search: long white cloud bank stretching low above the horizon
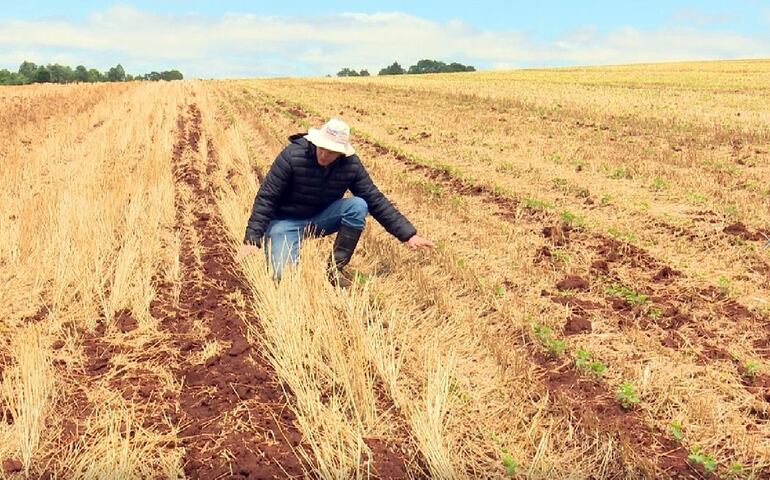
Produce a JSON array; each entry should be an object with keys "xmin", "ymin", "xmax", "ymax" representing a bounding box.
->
[{"xmin": 0, "ymin": 6, "xmax": 770, "ymax": 77}]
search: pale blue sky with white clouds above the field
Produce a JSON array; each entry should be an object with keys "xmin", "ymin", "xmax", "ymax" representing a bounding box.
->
[{"xmin": 0, "ymin": 0, "xmax": 770, "ymax": 78}]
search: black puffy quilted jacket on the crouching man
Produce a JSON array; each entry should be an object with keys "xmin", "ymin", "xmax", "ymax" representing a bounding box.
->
[{"xmin": 244, "ymin": 133, "xmax": 417, "ymax": 245}]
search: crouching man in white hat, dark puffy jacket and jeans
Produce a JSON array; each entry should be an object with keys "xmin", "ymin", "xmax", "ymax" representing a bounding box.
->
[{"xmin": 236, "ymin": 119, "xmax": 434, "ymax": 287}]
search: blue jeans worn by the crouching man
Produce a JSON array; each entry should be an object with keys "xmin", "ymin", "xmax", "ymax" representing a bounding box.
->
[{"xmin": 264, "ymin": 197, "xmax": 369, "ymax": 280}]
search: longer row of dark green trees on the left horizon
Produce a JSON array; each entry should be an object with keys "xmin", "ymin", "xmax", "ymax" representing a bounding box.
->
[{"xmin": 0, "ymin": 61, "xmax": 184, "ymax": 85}]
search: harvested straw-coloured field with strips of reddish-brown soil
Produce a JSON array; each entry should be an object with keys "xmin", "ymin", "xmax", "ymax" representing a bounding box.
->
[{"xmin": 0, "ymin": 61, "xmax": 770, "ymax": 479}]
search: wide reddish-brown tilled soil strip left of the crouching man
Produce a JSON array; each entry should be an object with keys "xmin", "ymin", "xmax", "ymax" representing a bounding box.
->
[{"xmin": 151, "ymin": 104, "xmax": 307, "ymax": 479}]
